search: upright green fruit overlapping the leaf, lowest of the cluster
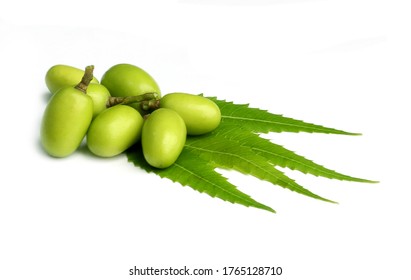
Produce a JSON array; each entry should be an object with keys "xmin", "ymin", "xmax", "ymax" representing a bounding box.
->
[{"xmin": 141, "ymin": 108, "xmax": 187, "ymax": 168}]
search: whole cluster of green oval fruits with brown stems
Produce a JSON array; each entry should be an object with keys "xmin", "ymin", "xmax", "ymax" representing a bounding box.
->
[{"xmin": 40, "ymin": 64, "xmax": 221, "ymax": 168}]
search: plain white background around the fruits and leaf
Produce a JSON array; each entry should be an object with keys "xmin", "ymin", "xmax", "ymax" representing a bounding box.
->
[{"xmin": 0, "ymin": 0, "xmax": 411, "ymax": 280}]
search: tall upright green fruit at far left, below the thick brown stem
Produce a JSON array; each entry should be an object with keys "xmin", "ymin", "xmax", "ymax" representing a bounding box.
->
[{"xmin": 40, "ymin": 87, "xmax": 93, "ymax": 157}]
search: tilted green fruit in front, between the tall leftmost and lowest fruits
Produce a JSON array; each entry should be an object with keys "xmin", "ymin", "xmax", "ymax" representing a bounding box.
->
[{"xmin": 87, "ymin": 105, "xmax": 143, "ymax": 157}]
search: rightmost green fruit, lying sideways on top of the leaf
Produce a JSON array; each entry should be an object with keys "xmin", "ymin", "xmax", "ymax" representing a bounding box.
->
[{"xmin": 160, "ymin": 92, "xmax": 221, "ymax": 135}]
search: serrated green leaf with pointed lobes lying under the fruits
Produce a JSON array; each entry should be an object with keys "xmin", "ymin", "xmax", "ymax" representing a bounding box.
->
[{"xmin": 126, "ymin": 97, "xmax": 373, "ymax": 212}]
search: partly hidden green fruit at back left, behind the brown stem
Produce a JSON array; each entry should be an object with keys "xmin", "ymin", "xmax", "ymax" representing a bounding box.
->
[{"xmin": 46, "ymin": 64, "xmax": 98, "ymax": 94}]
